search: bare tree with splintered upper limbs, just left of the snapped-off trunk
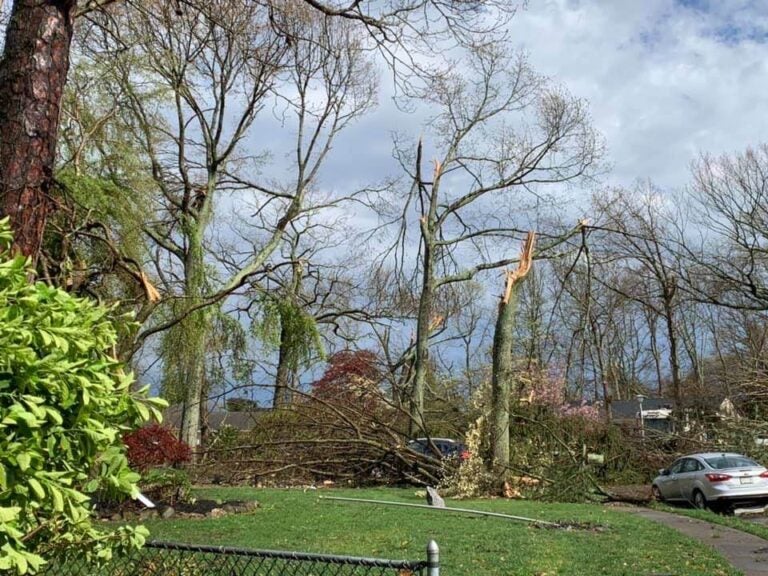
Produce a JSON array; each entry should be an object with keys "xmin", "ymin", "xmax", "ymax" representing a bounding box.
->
[{"xmin": 384, "ymin": 45, "xmax": 602, "ymax": 430}]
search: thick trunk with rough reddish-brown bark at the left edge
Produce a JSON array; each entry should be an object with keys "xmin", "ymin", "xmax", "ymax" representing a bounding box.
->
[{"xmin": 0, "ymin": 0, "xmax": 77, "ymax": 258}]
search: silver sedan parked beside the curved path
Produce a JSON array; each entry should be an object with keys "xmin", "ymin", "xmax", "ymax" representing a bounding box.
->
[{"xmin": 652, "ymin": 452, "xmax": 768, "ymax": 508}]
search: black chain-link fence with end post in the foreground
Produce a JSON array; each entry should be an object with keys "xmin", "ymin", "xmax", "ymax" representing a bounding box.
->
[{"xmin": 45, "ymin": 541, "xmax": 440, "ymax": 576}]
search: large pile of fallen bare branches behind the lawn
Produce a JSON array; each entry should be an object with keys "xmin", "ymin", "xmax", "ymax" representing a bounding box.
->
[{"xmin": 195, "ymin": 392, "xmax": 452, "ymax": 486}]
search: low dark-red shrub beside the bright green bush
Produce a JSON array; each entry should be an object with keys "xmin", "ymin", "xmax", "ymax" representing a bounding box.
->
[{"xmin": 123, "ymin": 424, "xmax": 191, "ymax": 472}]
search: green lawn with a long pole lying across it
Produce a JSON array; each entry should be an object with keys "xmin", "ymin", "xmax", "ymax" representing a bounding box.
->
[{"xmin": 132, "ymin": 488, "xmax": 739, "ymax": 576}]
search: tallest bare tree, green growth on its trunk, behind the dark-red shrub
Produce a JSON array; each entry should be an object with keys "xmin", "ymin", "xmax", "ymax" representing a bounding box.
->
[{"xmin": 78, "ymin": 0, "xmax": 375, "ymax": 446}]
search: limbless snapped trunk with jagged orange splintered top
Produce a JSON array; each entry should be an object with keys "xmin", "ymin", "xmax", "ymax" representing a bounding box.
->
[{"xmin": 491, "ymin": 232, "xmax": 535, "ymax": 475}]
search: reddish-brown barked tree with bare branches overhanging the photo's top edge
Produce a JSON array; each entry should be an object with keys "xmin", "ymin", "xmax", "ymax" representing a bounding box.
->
[{"xmin": 0, "ymin": 0, "xmax": 516, "ymax": 258}]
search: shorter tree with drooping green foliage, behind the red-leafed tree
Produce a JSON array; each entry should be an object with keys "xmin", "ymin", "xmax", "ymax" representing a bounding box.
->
[{"xmin": 235, "ymin": 213, "xmax": 374, "ymax": 408}]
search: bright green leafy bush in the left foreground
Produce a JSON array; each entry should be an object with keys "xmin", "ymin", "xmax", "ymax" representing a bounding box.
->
[{"xmin": 0, "ymin": 219, "xmax": 166, "ymax": 574}]
